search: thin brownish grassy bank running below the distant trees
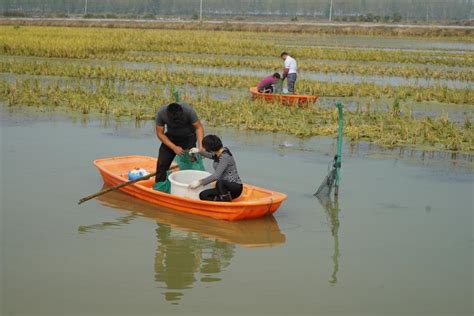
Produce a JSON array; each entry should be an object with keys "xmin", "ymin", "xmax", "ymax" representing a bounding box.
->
[{"xmin": 0, "ymin": 20, "xmax": 474, "ymax": 38}]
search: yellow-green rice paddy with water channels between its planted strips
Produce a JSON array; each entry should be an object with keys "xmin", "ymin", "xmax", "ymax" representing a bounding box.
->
[{"xmin": 0, "ymin": 26, "xmax": 474, "ymax": 153}]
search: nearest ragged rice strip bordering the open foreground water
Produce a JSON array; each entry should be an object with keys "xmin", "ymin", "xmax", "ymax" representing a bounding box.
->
[{"xmin": 0, "ymin": 80, "xmax": 474, "ymax": 153}]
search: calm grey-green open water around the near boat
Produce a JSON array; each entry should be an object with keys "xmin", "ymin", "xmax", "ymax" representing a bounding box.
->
[{"xmin": 0, "ymin": 108, "xmax": 474, "ymax": 315}]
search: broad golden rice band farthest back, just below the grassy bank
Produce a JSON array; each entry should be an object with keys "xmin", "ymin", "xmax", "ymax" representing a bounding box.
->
[{"xmin": 0, "ymin": 26, "xmax": 474, "ymax": 67}]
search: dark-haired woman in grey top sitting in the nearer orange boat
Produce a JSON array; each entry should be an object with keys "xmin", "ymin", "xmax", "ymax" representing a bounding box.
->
[{"xmin": 189, "ymin": 135, "xmax": 243, "ymax": 202}]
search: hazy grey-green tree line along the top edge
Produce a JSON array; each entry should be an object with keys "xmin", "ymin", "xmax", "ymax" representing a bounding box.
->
[{"xmin": 0, "ymin": 0, "xmax": 474, "ymax": 22}]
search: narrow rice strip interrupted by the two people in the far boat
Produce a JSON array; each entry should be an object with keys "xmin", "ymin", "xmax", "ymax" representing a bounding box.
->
[{"xmin": 0, "ymin": 61, "xmax": 474, "ymax": 104}]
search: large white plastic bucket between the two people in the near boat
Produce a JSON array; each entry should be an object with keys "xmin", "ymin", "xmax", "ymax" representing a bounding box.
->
[{"xmin": 168, "ymin": 170, "xmax": 213, "ymax": 200}]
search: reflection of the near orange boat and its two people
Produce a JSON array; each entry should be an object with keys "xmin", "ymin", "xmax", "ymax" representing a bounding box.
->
[{"xmin": 78, "ymin": 192, "xmax": 286, "ymax": 304}]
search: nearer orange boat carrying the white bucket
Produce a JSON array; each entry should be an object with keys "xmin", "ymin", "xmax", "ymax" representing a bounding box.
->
[{"xmin": 94, "ymin": 156, "xmax": 287, "ymax": 221}]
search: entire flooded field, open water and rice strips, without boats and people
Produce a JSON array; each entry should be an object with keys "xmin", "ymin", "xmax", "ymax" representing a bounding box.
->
[{"xmin": 0, "ymin": 26, "xmax": 474, "ymax": 315}]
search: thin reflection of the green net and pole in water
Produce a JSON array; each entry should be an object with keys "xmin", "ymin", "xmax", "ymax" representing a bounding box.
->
[{"xmin": 317, "ymin": 197, "xmax": 341, "ymax": 284}]
